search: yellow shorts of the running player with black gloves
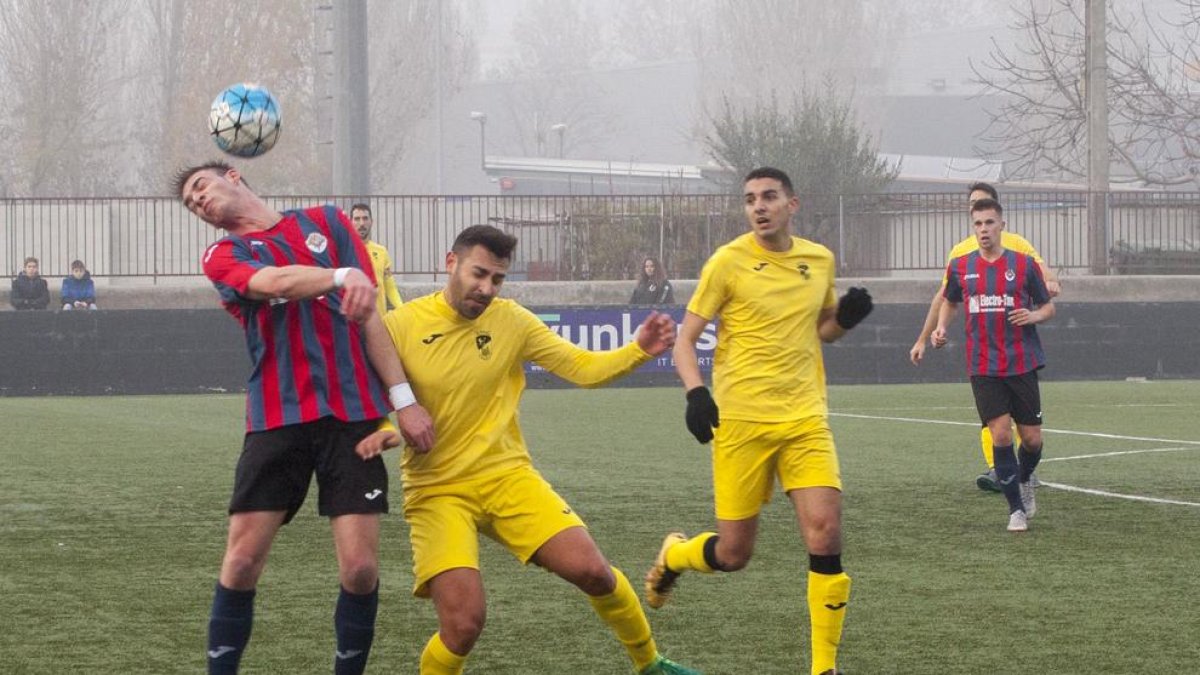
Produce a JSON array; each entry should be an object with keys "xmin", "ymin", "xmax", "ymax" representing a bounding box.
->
[{"xmin": 713, "ymin": 416, "xmax": 841, "ymax": 520}]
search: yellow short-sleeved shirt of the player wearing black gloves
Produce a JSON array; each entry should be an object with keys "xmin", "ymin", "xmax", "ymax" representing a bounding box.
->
[{"xmin": 688, "ymin": 233, "xmax": 838, "ymax": 422}]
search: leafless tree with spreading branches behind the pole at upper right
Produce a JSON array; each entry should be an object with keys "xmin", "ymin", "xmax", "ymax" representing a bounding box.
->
[{"xmin": 972, "ymin": 0, "xmax": 1200, "ymax": 186}]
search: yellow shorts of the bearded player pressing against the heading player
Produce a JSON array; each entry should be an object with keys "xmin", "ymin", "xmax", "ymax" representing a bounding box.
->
[{"xmin": 404, "ymin": 467, "xmax": 586, "ymax": 598}]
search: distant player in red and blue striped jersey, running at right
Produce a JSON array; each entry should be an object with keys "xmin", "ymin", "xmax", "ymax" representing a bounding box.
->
[{"xmin": 930, "ymin": 198, "xmax": 1055, "ymax": 532}]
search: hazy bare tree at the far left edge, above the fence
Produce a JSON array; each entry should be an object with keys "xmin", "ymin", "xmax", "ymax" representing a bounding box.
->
[{"xmin": 0, "ymin": 0, "xmax": 136, "ymax": 197}]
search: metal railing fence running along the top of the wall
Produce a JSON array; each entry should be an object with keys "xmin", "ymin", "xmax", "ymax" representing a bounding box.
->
[{"xmin": 0, "ymin": 191, "xmax": 1200, "ymax": 281}]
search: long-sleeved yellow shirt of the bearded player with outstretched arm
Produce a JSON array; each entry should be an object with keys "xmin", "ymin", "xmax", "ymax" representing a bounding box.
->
[{"xmin": 384, "ymin": 291, "xmax": 650, "ymax": 488}]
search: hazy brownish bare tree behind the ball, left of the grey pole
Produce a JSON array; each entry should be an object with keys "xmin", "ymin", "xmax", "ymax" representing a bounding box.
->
[{"xmin": 133, "ymin": 0, "xmax": 329, "ymax": 193}]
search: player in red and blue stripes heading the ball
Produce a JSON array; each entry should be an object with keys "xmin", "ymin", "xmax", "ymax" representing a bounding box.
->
[{"xmin": 175, "ymin": 162, "xmax": 434, "ymax": 675}]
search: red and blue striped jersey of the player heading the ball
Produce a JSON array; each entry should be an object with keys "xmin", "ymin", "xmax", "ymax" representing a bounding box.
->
[{"xmin": 204, "ymin": 205, "xmax": 391, "ymax": 431}]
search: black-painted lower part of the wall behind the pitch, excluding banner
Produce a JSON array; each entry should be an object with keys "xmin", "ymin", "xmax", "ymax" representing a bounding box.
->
[{"xmin": 0, "ymin": 301, "xmax": 1200, "ymax": 396}]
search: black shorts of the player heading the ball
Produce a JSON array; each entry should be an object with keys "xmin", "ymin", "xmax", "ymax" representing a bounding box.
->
[{"xmin": 229, "ymin": 417, "xmax": 388, "ymax": 522}]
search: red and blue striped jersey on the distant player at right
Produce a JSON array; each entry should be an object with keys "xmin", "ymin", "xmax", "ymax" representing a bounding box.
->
[{"xmin": 943, "ymin": 249, "xmax": 1050, "ymax": 377}]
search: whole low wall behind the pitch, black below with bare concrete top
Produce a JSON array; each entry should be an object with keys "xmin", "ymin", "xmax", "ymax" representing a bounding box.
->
[{"xmin": 0, "ymin": 277, "xmax": 1200, "ymax": 395}]
